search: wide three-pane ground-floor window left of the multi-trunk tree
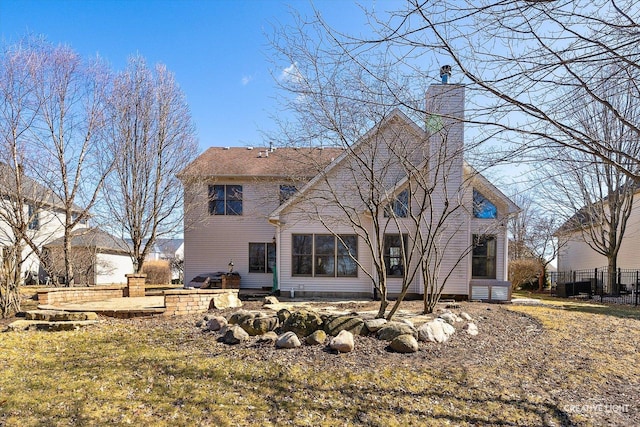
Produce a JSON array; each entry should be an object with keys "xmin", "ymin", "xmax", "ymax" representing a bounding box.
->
[{"xmin": 292, "ymin": 234, "xmax": 358, "ymax": 277}]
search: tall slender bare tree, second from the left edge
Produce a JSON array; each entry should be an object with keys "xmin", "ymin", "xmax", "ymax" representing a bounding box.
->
[{"xmin": 23, "ymin": 41, "xmax": 110, "ymax": 285}]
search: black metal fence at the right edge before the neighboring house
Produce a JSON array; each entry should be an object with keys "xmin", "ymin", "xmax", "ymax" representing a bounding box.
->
[{"xmin": 551, "ymin": 267, "xmax": 640, "ymax": 305}]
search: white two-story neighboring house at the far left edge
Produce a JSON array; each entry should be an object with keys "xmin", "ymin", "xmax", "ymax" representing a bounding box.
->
[{"xmin": 0, "ymin": 163, "xmax": 85, "ymax": 282}]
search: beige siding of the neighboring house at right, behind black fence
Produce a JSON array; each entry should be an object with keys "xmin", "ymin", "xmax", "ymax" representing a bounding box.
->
[{"xmin": 558, "ymin": 193, "xmax": 640, "ymax": 272}]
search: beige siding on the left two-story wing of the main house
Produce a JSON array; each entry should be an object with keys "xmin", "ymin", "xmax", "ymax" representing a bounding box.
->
[{"xmin": 184, "ymin": 180, "xmax": 280, "ymax": 288}]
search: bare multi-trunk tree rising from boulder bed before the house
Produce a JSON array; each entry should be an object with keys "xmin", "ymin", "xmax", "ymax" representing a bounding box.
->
[{"xmin": 273, "ymin": 16, "xmax": 508, "ymax": 318}]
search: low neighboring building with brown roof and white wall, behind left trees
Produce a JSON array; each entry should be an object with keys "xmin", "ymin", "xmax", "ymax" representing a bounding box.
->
[{"xmin": 45, "ymin": 228, "xmax": 134, "ymax": 285}]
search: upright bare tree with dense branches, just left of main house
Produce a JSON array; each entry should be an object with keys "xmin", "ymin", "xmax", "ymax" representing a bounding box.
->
[{"xmin": 104, "ymin": 56, "xmax": 197, "ymax": 272}]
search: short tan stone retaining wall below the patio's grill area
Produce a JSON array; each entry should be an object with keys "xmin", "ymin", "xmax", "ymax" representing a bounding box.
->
[{"xmin": 163, "ymin": 289, "xmax": 241, "ymax": 316}]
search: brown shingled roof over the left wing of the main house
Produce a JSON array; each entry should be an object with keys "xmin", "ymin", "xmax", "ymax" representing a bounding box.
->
[{"xmin": 178, "ymin": 147, "xmax": 343, "ymax": 181}]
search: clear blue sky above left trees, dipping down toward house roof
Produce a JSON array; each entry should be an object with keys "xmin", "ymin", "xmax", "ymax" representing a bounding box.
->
[{"xmin": 0, "ymin": 0, "xmax": 380, "ymax": 154}]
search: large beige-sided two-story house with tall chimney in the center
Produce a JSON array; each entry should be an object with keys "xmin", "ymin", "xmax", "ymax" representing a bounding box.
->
[{"xmin": 180, "ymin": 84, "xmax": 518, "ymax": 299}]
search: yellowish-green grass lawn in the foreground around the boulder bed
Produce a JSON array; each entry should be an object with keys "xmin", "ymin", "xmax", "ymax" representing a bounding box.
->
[{"xmin": 0, "ymin": 305, "xmax": 640, "ymax": 426}]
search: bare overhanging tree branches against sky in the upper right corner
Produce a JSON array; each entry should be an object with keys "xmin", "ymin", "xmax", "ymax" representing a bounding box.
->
[{"xmin": 362, "ymin": 0, "xmax": 640, "ymax": 179}]
